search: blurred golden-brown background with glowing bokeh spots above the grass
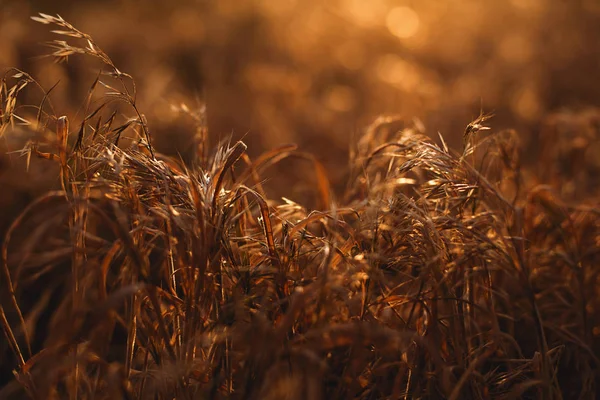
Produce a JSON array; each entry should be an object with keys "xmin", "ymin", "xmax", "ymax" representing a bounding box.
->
[{"xmin": 0, "ymin": 0, "xmax": 600, "ymax": 206}]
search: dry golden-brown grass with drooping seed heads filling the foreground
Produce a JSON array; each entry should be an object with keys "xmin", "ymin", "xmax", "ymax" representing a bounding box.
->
[{"xmin": 0, "ymin": 15, "xmax": 600, "ymax": 399}]
